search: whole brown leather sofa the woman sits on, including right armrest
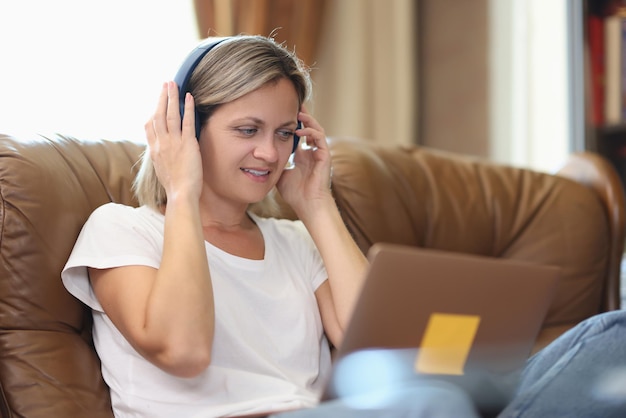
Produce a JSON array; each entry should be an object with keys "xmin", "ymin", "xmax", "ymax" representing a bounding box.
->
[{"xmin": 0, "ymin": 135, "xmax": 625, "ymax": 418}]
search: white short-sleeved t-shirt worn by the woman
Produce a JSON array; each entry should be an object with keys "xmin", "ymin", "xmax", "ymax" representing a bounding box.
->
[{"xmin": 62, "ymin": 203, "xmax": 331, "ymax": 418}]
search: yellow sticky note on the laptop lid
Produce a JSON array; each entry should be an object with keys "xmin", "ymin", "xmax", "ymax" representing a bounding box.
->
[{"xmin": 415, "ymin": 313, "xmax": 480, "ymax": 375}]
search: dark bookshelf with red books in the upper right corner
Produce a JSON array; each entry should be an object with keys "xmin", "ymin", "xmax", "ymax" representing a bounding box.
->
[{"xmin": 582, "ymin": 0, "xmax": 626, "ymax": 185}]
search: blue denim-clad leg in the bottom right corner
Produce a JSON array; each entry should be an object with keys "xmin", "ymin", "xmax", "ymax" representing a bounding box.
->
[{"xmin": 500, "ymin": 310, "xmax": 626, "ymax": 418}]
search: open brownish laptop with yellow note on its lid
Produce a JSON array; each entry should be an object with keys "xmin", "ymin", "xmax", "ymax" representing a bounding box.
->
[{"xmin": 322, "ymin": 243, "xmax": 560, "ymax": 416}]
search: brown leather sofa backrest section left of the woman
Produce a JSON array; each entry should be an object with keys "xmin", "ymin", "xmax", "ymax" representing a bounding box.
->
[{"xmin": 0, "ymin": 135, "xmax": 143, "ymax": 418}]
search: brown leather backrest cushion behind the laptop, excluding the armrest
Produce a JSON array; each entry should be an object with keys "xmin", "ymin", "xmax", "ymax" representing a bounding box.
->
[{"xmin": 332, "ymin": 140, "xmax": 610, "ymax": 332}]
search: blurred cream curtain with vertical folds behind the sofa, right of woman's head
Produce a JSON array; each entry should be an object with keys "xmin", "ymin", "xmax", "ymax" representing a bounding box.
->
[{"xmin": 310, "ymin": 0, "xmax": 419, "ymax": 144}]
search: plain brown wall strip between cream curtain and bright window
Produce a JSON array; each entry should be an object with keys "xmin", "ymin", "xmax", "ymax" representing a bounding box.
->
[{"xmin": 418, "ymin": 0, "xmax": 490, "ymax": 157}]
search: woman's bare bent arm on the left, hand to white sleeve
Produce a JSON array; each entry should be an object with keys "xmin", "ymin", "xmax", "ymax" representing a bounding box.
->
[{"xmin": 89, "ymin": 83, "xmax": 214, "ymax": 376}]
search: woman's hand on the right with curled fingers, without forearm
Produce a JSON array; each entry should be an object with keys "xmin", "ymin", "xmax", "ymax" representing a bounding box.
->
[{"xmin": 276, "ymin": 110, "xmax": 332, "ymax": 219}]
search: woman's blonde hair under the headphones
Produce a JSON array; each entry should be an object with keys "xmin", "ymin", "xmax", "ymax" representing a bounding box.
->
[{"xmin": 133, "ymin": 35, "xmax": 311, "ymax": 213}]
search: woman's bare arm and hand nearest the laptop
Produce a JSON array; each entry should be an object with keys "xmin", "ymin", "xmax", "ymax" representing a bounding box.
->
[{"xmin": 278, "ymin": 112, "xmax": 368, "ymax": 346}]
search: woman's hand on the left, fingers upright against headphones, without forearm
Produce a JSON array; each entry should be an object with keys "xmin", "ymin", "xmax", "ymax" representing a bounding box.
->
[{"xmin": 145, "ymin": 81, "xmax": 202, "ymax": 201}]
